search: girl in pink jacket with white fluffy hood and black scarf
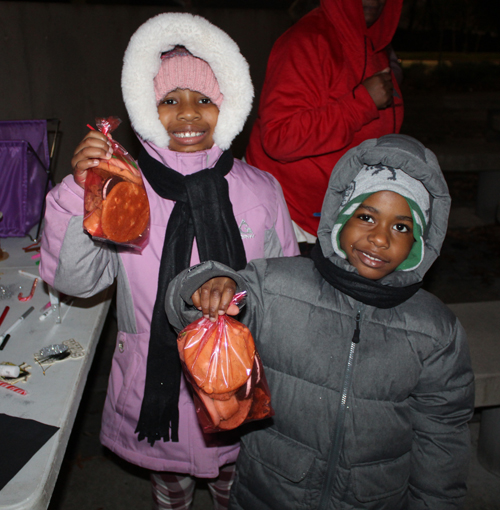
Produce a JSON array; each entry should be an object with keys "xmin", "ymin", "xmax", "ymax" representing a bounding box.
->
[{"xmin": 40, "ymin": 13, "xmax": 298, "ymax": 509}]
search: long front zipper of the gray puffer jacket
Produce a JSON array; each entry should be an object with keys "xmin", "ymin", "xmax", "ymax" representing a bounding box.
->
[{"xmin": 318, "ymin": 304, "xmax": 364, "ymax": 510}]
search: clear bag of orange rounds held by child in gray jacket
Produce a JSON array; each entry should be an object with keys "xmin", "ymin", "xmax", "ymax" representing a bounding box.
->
[{"xmin": 177, "ymin": 293, "xmax": 274, "ymax": 432}]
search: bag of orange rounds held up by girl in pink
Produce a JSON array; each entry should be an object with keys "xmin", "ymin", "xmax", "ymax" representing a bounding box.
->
[{"xmin": 83, "ymin": 117, "xmax": 149, "ymax": 249}]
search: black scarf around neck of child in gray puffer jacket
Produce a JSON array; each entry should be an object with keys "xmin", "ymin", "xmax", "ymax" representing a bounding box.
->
[{"xmin": 311, "ymin": 240, "xmax": 422, "ymax": 308}]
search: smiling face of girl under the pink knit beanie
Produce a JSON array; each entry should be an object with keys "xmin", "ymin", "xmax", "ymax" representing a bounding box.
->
[{"xmin": 158, "ymin": 89, "xmax": 219, "ymax": 152}]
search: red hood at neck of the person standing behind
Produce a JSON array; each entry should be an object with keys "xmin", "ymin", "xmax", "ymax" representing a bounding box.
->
[{"xmin": 320, "ymin": 0, "xmax": 403, "ymax": 52}]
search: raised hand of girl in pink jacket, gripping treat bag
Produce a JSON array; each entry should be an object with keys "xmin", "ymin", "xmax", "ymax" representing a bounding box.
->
[{"xmin": 71, "ymin": 131, "xmax": 113, "ymax": 188}]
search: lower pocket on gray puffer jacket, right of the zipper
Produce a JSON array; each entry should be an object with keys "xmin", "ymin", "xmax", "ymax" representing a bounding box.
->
[{"xmin": 351, "ymin": 452, "xmax": 410, "ymax": 502}]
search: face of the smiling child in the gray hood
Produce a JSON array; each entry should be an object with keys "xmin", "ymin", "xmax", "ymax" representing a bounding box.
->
[{"xmin": 340, "ymin": 191, "xmax": 414, "ymax": 280}]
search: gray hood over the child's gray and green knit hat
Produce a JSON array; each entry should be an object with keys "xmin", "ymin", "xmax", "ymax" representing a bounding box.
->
[{"xmin": 318, "ymin": 134, "xmax": 451, "ymax": 287}]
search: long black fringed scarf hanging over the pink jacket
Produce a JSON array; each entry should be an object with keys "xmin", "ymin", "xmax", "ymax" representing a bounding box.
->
[{"xmin": 135, "ymin": 145, "xmax": 246, "ymax": 446}]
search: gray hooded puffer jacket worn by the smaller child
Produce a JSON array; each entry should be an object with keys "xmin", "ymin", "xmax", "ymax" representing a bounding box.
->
[{"xmin": 166, "ymin": 135, "xmax": 474, "ymax": 510}]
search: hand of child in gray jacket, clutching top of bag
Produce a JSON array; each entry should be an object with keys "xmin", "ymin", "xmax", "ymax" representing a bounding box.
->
[{"xmin": 191, "ymin": 276, "xmax": 240, "ymax": 322}]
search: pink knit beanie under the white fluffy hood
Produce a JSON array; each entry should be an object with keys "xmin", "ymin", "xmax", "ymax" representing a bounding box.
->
[{"xmin": 154, "ymin": 46, "xmax": 224, "ymax": 110}]
